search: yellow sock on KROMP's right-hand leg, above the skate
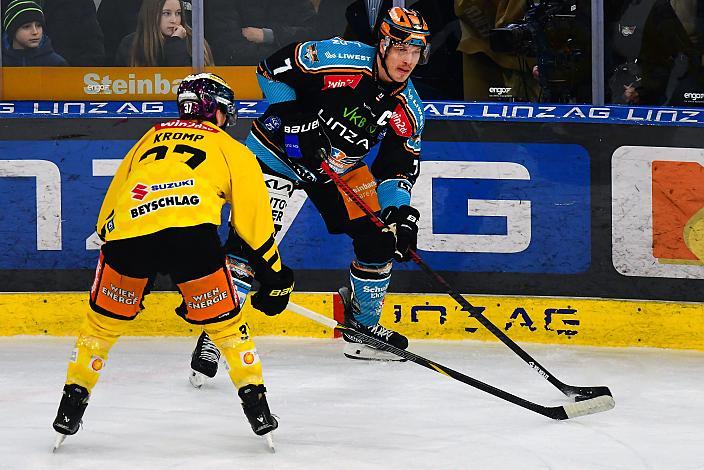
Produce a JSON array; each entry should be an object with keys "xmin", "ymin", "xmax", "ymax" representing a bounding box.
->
[{"xmin": 205, "ymin": 313, "xmax": 264, "ymax": 389}]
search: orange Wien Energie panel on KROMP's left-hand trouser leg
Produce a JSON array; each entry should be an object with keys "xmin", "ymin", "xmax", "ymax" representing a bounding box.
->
[{"xmin": 90, "ymin": 253, "xmax": 149, "ymax": 320}]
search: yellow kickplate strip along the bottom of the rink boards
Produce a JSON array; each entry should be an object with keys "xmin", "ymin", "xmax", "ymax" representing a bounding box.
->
[{"xmin": 0, "ymin": 292, "xmax": 704, "ymax": 350}]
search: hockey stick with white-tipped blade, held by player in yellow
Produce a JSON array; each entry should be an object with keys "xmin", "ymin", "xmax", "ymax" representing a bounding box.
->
[{"xmin": 286, "ymin": 302, "xmax": 616, "ymax": 420}]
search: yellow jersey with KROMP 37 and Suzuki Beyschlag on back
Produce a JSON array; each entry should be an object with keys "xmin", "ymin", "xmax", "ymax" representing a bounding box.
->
[{"xmin": 97, "ymin": 119, "xmax": 281, "ymax": 272}]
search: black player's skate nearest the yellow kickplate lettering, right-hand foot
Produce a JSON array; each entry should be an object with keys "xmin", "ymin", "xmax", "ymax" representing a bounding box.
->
[{"xmin": 338, "ymin": 287, "xmax": 408, "ymax": 362}]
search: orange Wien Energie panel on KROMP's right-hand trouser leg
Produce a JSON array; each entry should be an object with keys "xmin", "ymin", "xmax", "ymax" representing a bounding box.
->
[{"xmin": 176, "ymin": 268, "xmax": 240, "ymax": 325}]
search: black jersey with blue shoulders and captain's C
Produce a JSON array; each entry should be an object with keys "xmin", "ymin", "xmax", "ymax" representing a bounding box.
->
[{"xmin": 252, "ymin": 38, "xmax": 424, "ymax": 204}]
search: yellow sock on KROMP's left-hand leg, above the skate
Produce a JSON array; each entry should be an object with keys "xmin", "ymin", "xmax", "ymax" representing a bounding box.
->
[{"xmin": 66, "ymin": 310, "xmax": 129, "ymax": 392}]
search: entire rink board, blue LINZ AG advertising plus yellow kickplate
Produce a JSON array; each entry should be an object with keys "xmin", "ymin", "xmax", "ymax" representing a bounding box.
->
[{"xmin": 0, "ymin": 101, "xmax": 704, "ymax": 349}]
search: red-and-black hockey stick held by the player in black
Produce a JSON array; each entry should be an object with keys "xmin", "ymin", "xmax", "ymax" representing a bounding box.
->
[{"xmin": 321, "ymin": 161, "xmax": 612, "ymax": 400}]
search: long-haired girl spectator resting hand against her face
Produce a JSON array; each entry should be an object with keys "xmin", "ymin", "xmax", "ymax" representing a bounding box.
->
[{"xmin": 115, "ymin": 0, "xmax": 213, "ymax": 67}]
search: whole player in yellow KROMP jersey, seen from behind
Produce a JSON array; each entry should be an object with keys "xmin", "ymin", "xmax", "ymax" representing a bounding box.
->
[{"xmin": 54, "ymin": 73, "xmax": 293, "ymax": 449}]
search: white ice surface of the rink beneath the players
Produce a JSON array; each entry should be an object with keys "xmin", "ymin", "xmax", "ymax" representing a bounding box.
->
[{"xmin": 0, "ymin": 337, "xmax": 704, "ymax": 470}]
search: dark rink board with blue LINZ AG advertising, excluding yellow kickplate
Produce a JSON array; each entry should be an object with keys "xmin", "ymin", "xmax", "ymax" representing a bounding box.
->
[{"xmin": 0, "ymin": 101, "xmax": 704, "ymax": 303}]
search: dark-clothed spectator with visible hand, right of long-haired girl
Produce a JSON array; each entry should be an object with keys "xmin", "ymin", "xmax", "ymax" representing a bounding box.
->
[{"xmin": 204, "ymin": 0, "xmax": 316, "ymax": 65}]
